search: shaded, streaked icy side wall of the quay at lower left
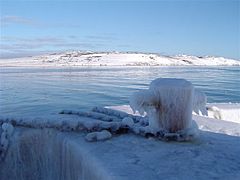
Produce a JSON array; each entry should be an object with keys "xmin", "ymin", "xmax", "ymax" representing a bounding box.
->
[{"xmin": 0, "ymin": 128, "xmax": 112, "ymax": 180}]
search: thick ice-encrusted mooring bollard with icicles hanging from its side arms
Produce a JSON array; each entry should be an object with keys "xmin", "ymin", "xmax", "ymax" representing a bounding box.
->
[{"xmin": 130, "ymin": 78, "xmax": 206, "ymax": 139}]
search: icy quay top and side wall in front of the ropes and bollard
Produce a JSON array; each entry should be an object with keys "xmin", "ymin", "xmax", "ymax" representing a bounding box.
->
[{"xmin": 0, "ymin": 125, "xmax": 240, "ymax": 180}]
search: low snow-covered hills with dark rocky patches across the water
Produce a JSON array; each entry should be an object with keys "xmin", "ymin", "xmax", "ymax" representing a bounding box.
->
[{"xmin": 0, "ymin": 51, "xmax": 240, "ymax": 67}]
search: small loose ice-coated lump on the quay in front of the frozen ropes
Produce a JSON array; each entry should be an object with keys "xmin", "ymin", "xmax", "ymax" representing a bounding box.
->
[{"xmin": 85, "ymin": 130, "xmax": 112, "ymax": 142}]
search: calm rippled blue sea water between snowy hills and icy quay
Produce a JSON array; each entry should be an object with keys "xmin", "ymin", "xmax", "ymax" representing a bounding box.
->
[{"xmin": 0, "ymin": 67, "xmax": 240, "ymax": 116}]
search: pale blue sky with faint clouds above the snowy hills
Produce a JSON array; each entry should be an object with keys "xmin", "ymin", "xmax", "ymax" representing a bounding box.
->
[{"xmin": 0, "ymin": 0, "xmax": 240, "ymax": 59}]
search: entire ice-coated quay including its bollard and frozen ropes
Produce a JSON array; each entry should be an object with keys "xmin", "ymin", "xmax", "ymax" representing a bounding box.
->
[{"xmin": 0, "ymin": 79, "xmax": 240, "ymax": 180}]
